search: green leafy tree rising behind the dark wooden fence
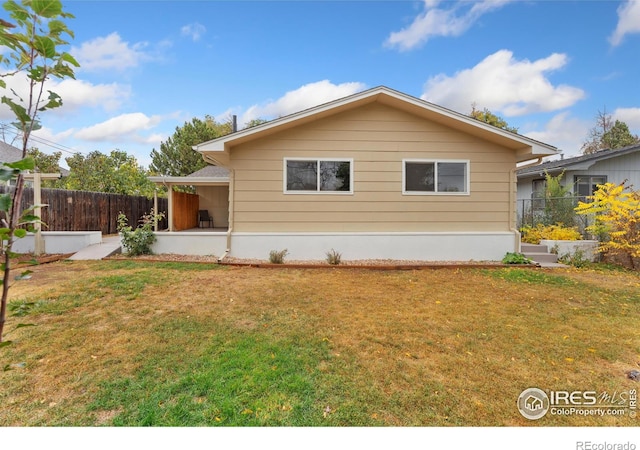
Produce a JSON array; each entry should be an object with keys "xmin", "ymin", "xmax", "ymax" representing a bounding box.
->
[{"xmin": 62, "ymin": 150, "xmax": 155, "ymax": 197}]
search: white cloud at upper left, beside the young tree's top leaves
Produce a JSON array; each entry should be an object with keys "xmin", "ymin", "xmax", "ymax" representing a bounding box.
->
[{"xmin": 70, "ymin": 32, "xmax": 150, "ymax": 72}]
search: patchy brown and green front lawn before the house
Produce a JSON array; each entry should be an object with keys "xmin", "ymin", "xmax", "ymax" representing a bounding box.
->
[{"xmin": 0, "ymin": 260, "xmax": 640, "ymax": 426}]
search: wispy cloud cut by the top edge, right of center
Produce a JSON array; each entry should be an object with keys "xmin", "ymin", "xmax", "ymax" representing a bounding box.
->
[{"xmin": 385, "ymin": 0, "xmax": 513, "ymax": 51}]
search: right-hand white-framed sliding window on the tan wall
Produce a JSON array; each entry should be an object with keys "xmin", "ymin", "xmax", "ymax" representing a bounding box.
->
[{"xmin": 402, "ymin": 159, "xmax": 469, "ymax": 195}]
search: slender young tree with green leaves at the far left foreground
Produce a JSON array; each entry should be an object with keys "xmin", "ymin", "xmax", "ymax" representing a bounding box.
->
[{"xmin": 0, "ymin": 0, "xmax": 79, "ymax": 342}]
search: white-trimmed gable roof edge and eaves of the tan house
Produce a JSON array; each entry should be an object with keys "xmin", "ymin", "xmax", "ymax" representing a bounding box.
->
[{"xmin": 193, "ymin": 86, "xmax": 558, "ymax": 166}]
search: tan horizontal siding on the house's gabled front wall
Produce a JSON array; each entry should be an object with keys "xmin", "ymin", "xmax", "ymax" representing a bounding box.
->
[{"xmin": 231, "ymin": 104, "xmax": 515, "ymax": 232}]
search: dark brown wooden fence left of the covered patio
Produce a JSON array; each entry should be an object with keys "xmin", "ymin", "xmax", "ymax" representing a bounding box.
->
[{"xmin": 0, "ymin": 186, "xmax": 168, "ymax": 234}]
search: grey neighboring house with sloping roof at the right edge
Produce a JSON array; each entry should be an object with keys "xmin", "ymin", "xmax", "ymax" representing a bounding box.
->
[{"xmin": 518, "ymin": 144, "xmax": 640, "ymax": 203}]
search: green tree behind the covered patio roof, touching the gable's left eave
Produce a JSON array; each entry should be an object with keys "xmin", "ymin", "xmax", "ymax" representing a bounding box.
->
[{"xmin": 149, "ymin": 116, "xmax": 232, "ymax": 177}]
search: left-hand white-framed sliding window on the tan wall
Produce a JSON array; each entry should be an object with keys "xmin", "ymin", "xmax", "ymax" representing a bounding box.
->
[{"xmin": 284, "ymin": 159, "xmax": 353, "ymax": 194}]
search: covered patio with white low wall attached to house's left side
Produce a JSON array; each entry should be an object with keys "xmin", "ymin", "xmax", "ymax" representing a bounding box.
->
[{"xmin": 149, "ymin": 166, "xmax": 229, "ymax": 257}]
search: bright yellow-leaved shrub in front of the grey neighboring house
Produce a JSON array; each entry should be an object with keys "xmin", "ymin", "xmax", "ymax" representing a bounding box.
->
[{"xmin": 576, "ymin": 182, "xmax": 640, "ymax": 269}]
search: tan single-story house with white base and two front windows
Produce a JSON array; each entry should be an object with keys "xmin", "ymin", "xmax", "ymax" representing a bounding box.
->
[{"xmin": 152, "ymin": 87, "xmax": 557, "ymax": 261}]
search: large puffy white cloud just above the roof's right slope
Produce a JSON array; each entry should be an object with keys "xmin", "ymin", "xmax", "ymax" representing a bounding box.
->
[{"xmin": 422, "ymin": 50, "xmax": 585, "ymax": 116}]
